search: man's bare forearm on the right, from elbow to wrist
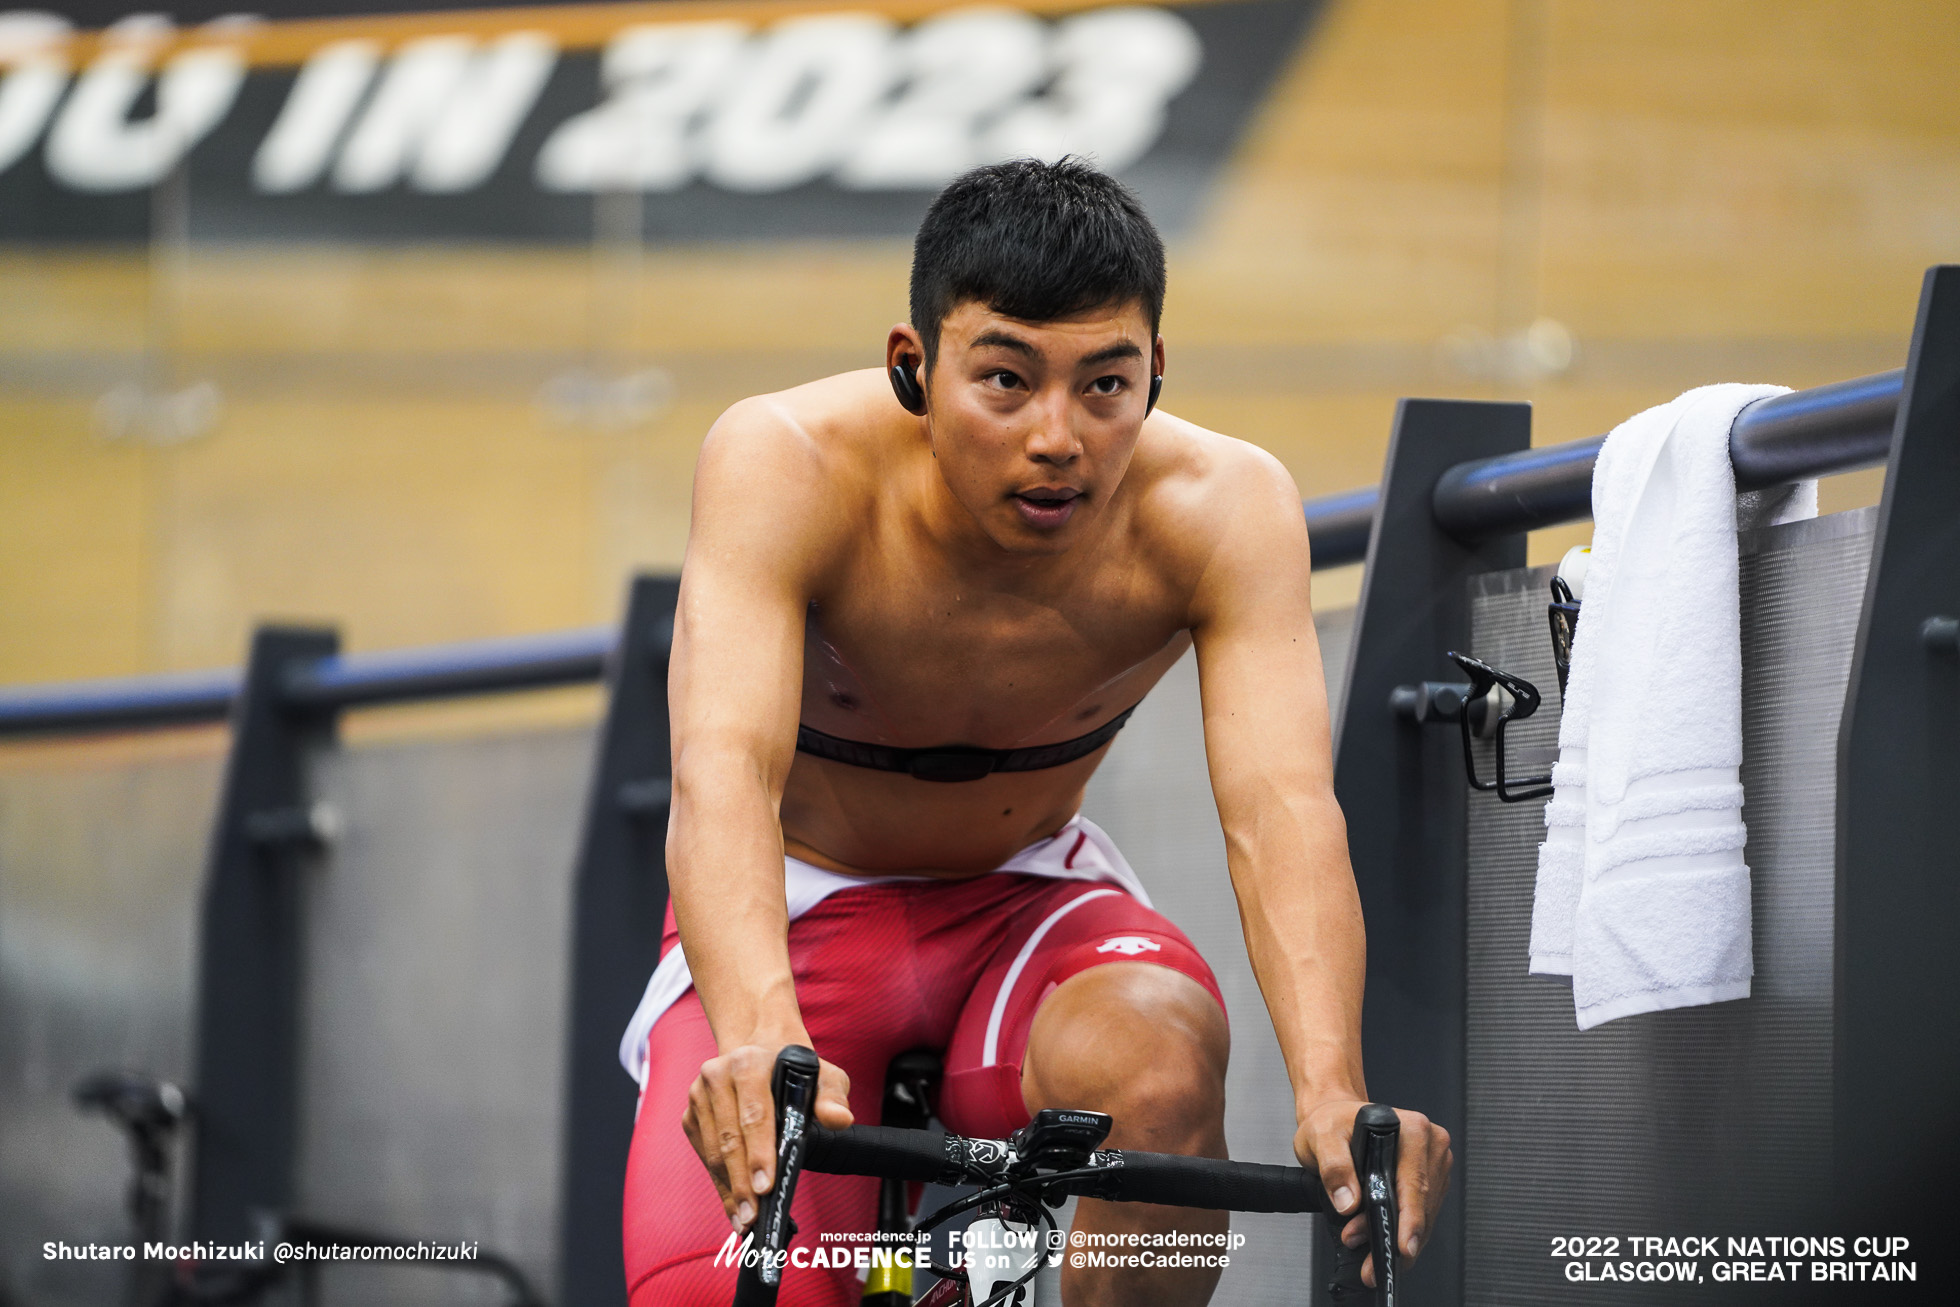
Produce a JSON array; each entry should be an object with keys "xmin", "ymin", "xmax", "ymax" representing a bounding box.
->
[{"xmin": 1227, "ymin": 798, "xmax": 1368, "ymax": 1109}]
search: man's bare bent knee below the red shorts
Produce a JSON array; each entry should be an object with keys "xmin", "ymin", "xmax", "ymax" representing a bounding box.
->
[{"xmin": 1021, "ymin": 962, "xmax": 1231, "ymax": 1150}]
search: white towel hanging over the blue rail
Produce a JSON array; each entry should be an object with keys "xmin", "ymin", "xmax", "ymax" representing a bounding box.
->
[{"xmin": 1531, "ymin": 384, "xmax": 1817, "ymax": 1029}]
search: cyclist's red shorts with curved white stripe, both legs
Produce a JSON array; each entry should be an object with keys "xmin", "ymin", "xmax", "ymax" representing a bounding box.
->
[{"xmin": 625, "ymin": 872, "xmax": 1225, "ymax": 1307}]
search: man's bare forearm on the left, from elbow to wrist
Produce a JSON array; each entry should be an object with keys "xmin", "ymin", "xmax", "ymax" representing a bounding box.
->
[{"xmin": 666, "ymin": 760, "xmax": 802, "ymax": 1048}]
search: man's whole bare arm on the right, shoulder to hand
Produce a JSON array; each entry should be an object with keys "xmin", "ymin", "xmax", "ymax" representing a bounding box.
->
[{"xmin": 1192, "ymin": 438, "xmax": 1450, "ymax": 1258}]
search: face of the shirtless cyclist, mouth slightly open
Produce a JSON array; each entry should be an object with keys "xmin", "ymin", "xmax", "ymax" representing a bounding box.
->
[{"xmin": 905, "ymin": 300, "xmax": 1162, "ymax": 555}]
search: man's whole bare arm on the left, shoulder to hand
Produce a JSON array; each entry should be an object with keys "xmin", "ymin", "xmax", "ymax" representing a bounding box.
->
[{"xmin": 666, "ymin": 400, "xmax": 851, "ymax": 1227}]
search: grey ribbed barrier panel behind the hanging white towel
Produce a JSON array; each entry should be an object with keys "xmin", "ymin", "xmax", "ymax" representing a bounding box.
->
[{"xmin": 1466, "ymin": 509, "xmax": 1876, "ymax": 1307}]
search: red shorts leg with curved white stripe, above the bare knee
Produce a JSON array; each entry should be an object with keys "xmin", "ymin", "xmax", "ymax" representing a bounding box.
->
[{"xmin": 939, "ymin": 880, "xmax": 1225, "ymax": 1138}]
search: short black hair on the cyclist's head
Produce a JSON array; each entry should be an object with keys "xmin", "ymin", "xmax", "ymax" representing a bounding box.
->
[{"xmin": 911, "ymin": 157, "xmax": 1164, "ymax": 364}]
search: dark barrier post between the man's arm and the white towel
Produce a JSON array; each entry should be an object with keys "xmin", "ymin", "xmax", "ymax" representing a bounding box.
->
[{"xmin": 1315, "ymin": 400, "xmax": 1531, "ymax": 1303}]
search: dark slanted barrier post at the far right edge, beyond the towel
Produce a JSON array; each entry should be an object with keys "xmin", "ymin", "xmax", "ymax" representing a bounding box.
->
[{"xmin": 1835, "ymin": 266, "xmax": 1960, "ymax": 1238}]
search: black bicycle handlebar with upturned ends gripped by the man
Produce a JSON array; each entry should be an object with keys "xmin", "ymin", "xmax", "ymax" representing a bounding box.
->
[{"xmin": 735, "ymin": 1044, "xmax": 1401, "ymax": 1307}]
